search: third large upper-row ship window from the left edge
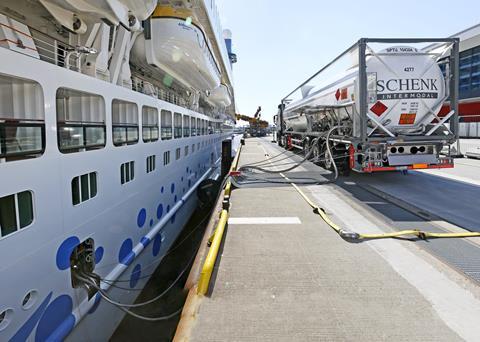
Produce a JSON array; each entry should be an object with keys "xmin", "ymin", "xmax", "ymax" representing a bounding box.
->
[{"xmin": 112, "ymin": 99, "xmax": 138, "ymax": 146}]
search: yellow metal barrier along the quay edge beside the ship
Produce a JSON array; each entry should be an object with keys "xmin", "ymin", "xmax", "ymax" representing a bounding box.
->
[{"xmin": 197, "ymin": 140, "xmax": 242, "ymax": 295}]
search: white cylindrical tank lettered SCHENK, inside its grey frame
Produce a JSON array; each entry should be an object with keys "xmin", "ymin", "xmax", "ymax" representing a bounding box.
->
[{"xmin": 284, "ymin": 46, "xmax": 446, "ymax": 134}]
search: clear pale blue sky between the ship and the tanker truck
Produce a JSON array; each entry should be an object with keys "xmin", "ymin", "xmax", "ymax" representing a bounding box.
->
[{"xmin": 216, "ymin": 0, "xmax": 480, "ymax": 122}]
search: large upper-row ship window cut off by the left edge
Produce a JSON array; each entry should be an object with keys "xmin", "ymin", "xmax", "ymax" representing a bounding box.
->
[{"xmin": 0, "ymin": 75, "xmax": 45, "ymax": 163}]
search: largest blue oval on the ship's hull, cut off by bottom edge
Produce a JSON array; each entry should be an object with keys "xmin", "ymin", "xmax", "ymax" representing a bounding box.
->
[{"xmin": 35, "ymin": 295, "xmax": 75, "ymax": 342}]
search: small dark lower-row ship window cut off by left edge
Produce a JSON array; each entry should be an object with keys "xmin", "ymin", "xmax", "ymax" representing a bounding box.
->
[{"xmin": 0, "ymin": 191, "xmax": 33, "ymax": 237}]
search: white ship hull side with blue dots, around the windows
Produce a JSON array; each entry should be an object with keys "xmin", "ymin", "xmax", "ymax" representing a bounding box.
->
[{"xmin": 0, "ymin": 49, "xmax": 230, "ymax": 341}]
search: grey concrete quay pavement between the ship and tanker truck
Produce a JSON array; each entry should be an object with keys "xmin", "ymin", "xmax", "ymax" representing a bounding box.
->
[{"xmin": 176, "ymin": 138, "xmax": 480, "ymax": 341}]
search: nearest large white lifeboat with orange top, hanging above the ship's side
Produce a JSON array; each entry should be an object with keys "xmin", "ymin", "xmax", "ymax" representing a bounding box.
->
[{"xmin": 132, "ymin": 6, "xmax": 220, "ymax": 91}]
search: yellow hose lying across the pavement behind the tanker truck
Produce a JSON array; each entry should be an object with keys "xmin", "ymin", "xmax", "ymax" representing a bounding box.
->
[{"xmin": 280, "ymin": 173, "xmax": 480, "ymax": 240}]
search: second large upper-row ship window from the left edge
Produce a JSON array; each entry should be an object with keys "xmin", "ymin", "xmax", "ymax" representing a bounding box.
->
[{"xmin": 56, "ymin": 88, "xmax": 105, "ymax": 153}]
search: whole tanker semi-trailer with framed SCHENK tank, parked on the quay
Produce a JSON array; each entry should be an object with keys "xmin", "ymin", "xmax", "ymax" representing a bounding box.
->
[{"xmin": 276, "ymin": 38, "xmax": 459, "ymax": 174}]
